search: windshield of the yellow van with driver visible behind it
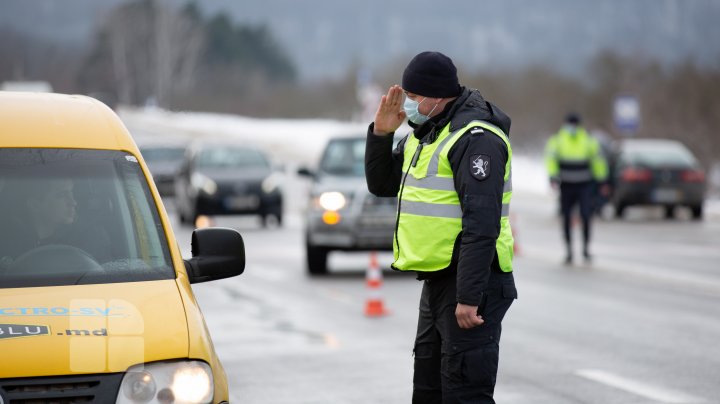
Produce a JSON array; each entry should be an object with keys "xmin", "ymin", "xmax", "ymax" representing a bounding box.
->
[{"xmin": 0, "ymin": 148, "xmax": 175, "ymax": 288}]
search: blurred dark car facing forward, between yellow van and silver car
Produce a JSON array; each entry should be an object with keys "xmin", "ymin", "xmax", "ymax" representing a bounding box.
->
[{"xmin": 175, "ymin": 140, "xmax": 283, "ymax": 226}]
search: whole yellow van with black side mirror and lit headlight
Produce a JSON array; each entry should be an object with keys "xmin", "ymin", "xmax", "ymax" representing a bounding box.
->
[{"xmin": 0, "ymin": 91, "xmax": 245, "ymax": 404}]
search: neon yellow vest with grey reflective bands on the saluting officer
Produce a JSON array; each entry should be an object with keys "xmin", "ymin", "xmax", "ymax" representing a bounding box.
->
[{"xmin": 392, "ymin": 121, "xmax": 514, "ymax": 272}]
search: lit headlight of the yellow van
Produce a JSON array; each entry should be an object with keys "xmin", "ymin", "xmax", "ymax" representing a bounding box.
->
[{"xmin": 116, "ymin": 361, "xmax": 215, "ymax": 404}]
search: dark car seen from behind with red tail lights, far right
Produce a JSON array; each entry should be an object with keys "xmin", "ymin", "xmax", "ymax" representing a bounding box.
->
[{"xmin": 611, "ymin": 139, "xmax": 705, "ymax": 219}]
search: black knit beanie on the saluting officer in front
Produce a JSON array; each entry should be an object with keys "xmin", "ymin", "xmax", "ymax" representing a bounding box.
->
[{"xmin": 402, "ymin": 52, "xmax": 460, "ymax": 98}]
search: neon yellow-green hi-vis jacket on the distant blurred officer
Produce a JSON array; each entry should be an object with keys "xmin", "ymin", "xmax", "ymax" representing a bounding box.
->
[{"xmin": 545, "ymin": 127, "xmax": 608, "ymax": 183}]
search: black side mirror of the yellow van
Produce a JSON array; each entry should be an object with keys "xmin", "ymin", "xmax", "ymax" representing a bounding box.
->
[{"xmin": 185, "ymin": 227, "xmax": 245, "ymax": 283}]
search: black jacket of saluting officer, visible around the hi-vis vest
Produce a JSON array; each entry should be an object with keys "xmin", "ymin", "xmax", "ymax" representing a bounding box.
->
[{"xmin": 365, "ymin": 88, "xmax": 510, "ymax": 306}]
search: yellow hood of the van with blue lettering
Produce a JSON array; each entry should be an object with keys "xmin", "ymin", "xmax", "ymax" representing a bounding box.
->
[{"xmin": 0, "ymin": 280, "xmax": 188, "ymax": 378}]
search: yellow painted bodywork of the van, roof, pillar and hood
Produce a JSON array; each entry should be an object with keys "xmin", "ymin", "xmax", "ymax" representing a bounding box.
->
[{"xmin": 0, "ymin": 91, "xmax": 228, "ymax": 403}]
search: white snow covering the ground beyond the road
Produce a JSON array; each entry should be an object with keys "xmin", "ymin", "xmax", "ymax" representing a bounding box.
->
[{"xmin": 119, "ymin": 108, "xmax": 720, "ymax": 217}]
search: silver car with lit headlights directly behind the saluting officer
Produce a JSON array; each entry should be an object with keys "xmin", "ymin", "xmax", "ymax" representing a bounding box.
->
[{"xmin": 298, "ymin": 136, "xmax": 397, "ymax": 275}]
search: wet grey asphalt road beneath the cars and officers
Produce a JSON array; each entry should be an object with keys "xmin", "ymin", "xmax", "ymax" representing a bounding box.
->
[{"xmin": 168, "ymin": 187, "xmax": 720, "ymax": 404}]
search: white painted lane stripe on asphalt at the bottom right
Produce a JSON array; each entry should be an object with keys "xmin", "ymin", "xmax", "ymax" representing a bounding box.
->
[{"xmin": 575, "ymin": 369, "xmax": 706, "ymax": 404}]
